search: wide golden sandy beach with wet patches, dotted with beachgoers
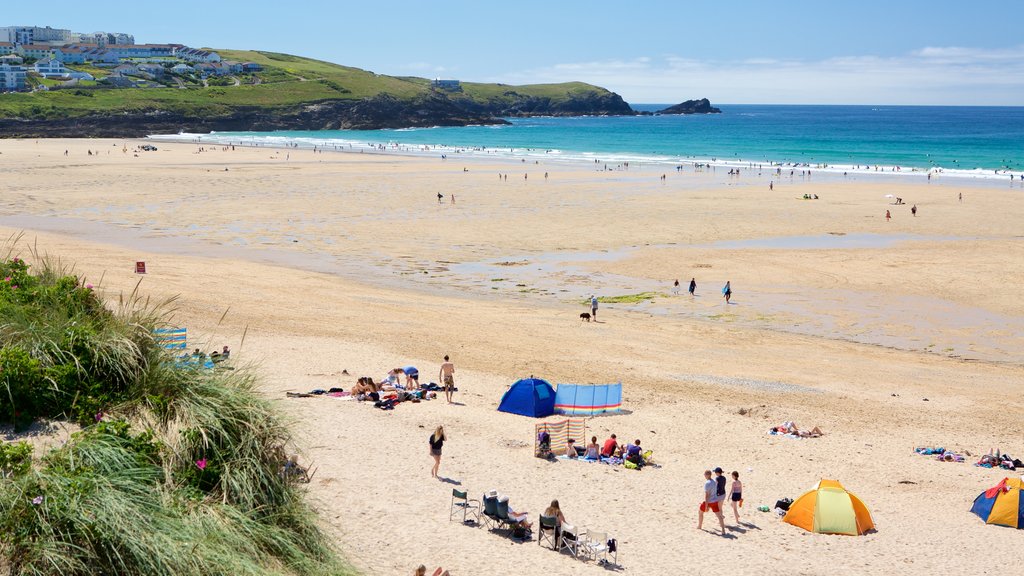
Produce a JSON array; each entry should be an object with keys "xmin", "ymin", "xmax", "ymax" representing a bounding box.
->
[{"xmin": 0, "ymin": 139, "xmax": 1024, "ymax": 575}]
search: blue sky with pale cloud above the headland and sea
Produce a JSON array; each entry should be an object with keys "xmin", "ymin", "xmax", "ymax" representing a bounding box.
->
[{"xmin": 0, "ymin": 0, "xmax": 1024, "ymax": 106}]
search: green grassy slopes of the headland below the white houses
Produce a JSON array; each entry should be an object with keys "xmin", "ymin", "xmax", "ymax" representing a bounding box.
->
[{"xmin": 0, "ymin": 49, "xmax": 608, "ymax": 120}]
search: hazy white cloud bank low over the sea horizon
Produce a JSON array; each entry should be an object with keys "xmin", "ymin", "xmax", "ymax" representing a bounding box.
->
[{"xmin": 489, "ymin": 46, "xmax": 1024, "ymax": 106}]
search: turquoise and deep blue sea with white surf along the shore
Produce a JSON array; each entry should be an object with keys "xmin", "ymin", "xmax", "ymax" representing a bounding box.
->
[{"xmin": 155, "ymin": 105, "xmax": 1024, "ymax": 178}]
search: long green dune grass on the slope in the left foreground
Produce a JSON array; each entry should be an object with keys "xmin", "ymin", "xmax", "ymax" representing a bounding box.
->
[{"xmin": 0, "ymin": 239, "xmax": 351, "ymax": 576}]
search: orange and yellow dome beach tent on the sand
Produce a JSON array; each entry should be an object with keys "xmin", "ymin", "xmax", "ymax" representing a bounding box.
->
[{"xmin": 782, "ymin": 480, "xmax": 874, "ymax": 536}]
